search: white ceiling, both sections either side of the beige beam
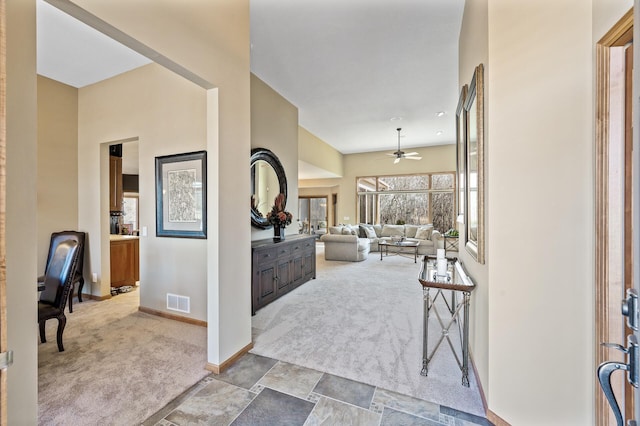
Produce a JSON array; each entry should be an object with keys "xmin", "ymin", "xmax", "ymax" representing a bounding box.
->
[{"xmin": 37, "ymin": 0, "xmax": 464, "ymax": 161}]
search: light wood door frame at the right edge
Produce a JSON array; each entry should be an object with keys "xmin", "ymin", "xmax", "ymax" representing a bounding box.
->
[{"xmin": 594, "ymin": 8, "xmax": 633, "ymax": 425}]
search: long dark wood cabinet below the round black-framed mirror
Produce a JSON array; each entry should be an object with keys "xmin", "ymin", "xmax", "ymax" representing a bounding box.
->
[{"xmin": 251, "ymin": 235, "xmax": 316, "ymax": 314}]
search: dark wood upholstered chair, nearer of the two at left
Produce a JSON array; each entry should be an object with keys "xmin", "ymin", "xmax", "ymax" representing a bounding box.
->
[{"xmin": 38, "ymin": 240, "xmax": 80, "ymax": 352}]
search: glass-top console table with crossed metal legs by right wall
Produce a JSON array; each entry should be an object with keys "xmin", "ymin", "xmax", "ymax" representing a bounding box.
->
[{"xmin": 418, "ymin": 256, "xmax": 476, "ymax": 387}]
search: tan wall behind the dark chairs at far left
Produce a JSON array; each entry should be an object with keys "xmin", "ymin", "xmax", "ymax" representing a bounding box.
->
[{"xmin": 37, "ymin": 76, "xmax": 79, "ymax": 272}]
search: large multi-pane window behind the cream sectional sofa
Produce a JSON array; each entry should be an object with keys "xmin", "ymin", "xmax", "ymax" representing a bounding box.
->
[{"xmin": 356, "ymin": 172, "xmax": 456, "ymax": 232}]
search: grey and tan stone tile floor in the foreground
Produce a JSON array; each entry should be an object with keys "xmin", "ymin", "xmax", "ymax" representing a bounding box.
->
[{"xmin": 143, "ymin": 353, "xmax": 491, "ymax": 426}]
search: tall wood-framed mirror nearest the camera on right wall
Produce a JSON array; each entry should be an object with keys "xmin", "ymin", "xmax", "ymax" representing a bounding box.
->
[{"xmin": 464, "ymin": 64, "xmax": 484, "ymax": 264}]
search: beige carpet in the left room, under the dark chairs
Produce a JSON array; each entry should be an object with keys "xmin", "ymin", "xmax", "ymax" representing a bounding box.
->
[{"xmin": 35, "ymin": 290, "xmax": 209, "ymax": 426}]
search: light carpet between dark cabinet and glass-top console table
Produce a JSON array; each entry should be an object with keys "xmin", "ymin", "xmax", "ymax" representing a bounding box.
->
[{"xmin": 251, "ymin": 244, "xmax": 484, "ymax": 416}]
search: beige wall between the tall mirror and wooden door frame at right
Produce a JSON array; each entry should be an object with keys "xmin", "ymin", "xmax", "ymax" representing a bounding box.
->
[{"xmin": 460, "ymin": 0, "xmax": 631, "ymax": 425}]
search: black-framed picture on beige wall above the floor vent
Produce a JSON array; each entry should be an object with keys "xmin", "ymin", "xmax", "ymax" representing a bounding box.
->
[{"xmin": 156, "ymin": 151, "xmax": 207, "ymax": 238}]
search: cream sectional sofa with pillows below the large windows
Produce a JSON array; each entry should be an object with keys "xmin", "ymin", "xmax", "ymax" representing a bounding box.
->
[{"xmin": 320, "ymin": 224, "xmax": 444, "ymax": 260}]
